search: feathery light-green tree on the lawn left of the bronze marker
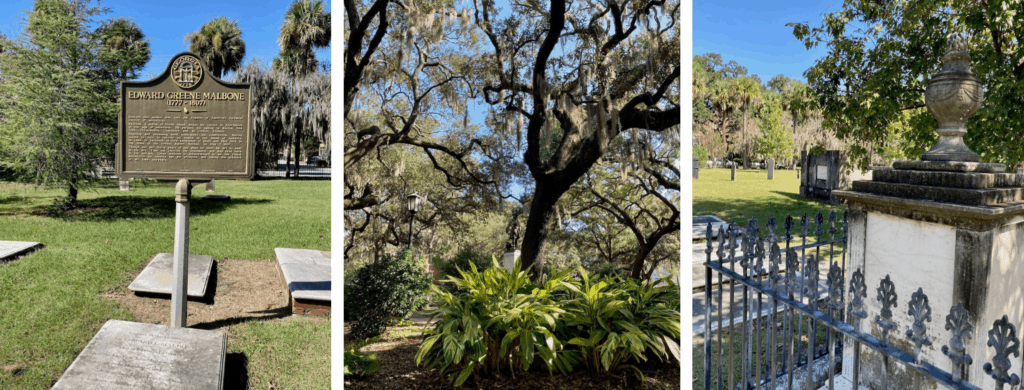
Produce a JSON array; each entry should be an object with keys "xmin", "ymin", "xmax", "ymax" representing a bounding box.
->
[{"xmin": 0, "ymin": 0, "xmax": 150, "ymax": 209}]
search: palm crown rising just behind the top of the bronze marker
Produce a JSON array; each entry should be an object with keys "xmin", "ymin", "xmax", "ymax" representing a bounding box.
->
[{"xmin": 185, "ymin": 16, "xmax": 246, "ymax": 79}]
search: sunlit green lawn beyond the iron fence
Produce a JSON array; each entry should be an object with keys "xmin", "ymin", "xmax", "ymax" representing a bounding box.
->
[{"xmin": 693, "ymin": 169, "xmax": 846, "ymax": 241}]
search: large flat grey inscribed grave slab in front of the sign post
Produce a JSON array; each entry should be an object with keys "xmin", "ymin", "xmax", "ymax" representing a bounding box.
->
[{"xmin": 53, "ymin": 319, "xmax": 227, "ymax": 390}]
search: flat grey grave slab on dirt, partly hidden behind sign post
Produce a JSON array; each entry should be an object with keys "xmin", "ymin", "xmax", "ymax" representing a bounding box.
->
[{"xmin": 128, "ymin": 253, "xmax": 213, "ymax": 298}]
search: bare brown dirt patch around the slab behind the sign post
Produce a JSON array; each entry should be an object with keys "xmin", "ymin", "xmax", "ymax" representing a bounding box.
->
[{"xmin": 99, "ymin": 260, "xmax": 292, "ymax": 335}]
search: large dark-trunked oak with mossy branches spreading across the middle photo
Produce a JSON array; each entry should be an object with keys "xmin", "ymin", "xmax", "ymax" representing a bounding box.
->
[{"xmin": 345, "ymin": 0, "xmax": 680, "ymax": 276}]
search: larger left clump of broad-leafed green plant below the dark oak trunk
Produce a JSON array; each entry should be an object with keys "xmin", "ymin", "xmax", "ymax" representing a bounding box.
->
[{"xmin": 416, "ymin": 259, "xmax": 578, "ymax": 386}]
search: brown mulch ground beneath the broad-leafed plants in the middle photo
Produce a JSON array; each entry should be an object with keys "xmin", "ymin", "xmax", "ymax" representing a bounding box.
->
[{"xmin": 344, "ymin": 327, "xmax": 681, "ymax": 390}]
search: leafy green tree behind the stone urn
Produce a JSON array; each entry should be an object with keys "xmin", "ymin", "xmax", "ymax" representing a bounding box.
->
[{"xmin": 787, "ymin": 0, "xmax": 1024, "ymax": 167}]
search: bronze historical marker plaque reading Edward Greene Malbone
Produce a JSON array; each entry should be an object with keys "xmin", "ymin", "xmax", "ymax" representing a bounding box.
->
[{"xmin": 116, "ymin": 52, "xmax": 256, "ymax": 181}]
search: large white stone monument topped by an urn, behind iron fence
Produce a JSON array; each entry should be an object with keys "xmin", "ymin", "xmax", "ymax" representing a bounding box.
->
[{"xmin": 833, "ymin": 34, "xmax": 1024, "ymax": 389}]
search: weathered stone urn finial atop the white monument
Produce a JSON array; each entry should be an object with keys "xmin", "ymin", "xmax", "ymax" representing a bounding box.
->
[{"xmin": 921, "ymin": 33, "xmax": 984, "ymax": 163}]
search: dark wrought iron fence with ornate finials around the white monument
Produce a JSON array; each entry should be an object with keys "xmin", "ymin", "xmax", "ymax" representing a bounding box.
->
[{"xmin": 703, "ymin": 211, "xmax": 1020, "ymax": 390}]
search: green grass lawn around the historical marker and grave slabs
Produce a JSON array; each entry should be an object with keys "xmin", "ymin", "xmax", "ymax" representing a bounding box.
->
[{"xmin": 0, "ymin": 180, "xmax": 331, "ymax": 389}]
